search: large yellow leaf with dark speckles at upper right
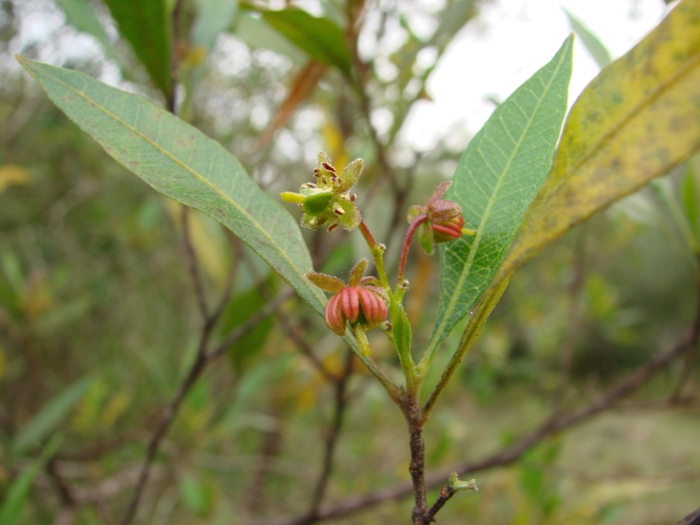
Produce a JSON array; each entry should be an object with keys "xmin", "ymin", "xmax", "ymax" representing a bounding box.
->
[{"xmin": 494, "ymin": 0, "xmax": 700, "ymax": 294}]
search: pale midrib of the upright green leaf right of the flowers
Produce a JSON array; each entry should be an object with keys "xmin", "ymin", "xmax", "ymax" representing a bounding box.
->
[{"xmin": 425, "ymin": 47, "xmax": 565, "ymax": 356}]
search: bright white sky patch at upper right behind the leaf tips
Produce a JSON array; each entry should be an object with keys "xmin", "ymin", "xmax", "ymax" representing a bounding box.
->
[{"xmin": 402, "ymin": 0, "xmax": 666, "ymax": 150}]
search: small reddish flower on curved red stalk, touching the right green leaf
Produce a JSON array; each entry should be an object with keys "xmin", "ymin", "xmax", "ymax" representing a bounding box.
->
[{"xmin": 408, "ymin": 181, "xmax": 474, "ymax": 255}]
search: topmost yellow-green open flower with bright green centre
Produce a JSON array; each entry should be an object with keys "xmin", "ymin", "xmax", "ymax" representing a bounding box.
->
[{"xmin": 280, "ymin": 152, "xmax": 363, "ymax": 232}]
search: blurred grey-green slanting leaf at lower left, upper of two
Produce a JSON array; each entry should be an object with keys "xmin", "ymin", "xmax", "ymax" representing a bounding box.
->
[{"xmin": 12, "ymin": 377, "xmax": 92, "ymax": 454}]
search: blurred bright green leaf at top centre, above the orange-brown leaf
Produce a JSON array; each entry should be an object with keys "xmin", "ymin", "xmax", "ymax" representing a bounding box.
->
[{"xmin": 248, "ymin": 6, "xmax": 352, "ymax": 76}]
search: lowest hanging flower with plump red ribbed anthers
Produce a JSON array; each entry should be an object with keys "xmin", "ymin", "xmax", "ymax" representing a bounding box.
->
[{"xmin": 306, "ymin": 259, "xmax": 388, "ymax": 335}]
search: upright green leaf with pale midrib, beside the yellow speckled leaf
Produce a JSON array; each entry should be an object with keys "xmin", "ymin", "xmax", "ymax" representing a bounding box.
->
[{"xmin": 426, "ymin": 37, "xmax": 573, "ymax": 362}]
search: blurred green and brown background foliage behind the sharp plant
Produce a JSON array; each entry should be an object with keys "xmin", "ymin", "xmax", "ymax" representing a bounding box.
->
[{"xmin": 0, "ymin": 0, "xmax": 700, "ymax": 525}]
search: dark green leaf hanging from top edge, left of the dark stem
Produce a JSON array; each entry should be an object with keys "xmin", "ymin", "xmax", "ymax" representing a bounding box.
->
[{"xmin": 105, "ymin": 0, "xmax": 173, "ymax": 99}]
